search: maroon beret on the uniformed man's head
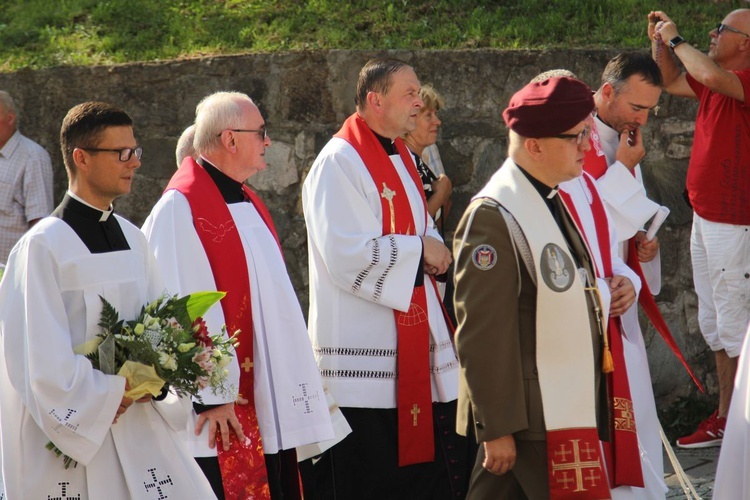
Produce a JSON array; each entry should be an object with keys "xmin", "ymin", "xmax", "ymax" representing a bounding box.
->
[{"xmin": 503, "ymin": 76, "xmax": 594, "ymax": 138}]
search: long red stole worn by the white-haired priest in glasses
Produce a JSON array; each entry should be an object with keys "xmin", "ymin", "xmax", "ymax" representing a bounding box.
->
[{"xmin": 165, "ymin": 158, "xmax": 279, "ymax": 499}]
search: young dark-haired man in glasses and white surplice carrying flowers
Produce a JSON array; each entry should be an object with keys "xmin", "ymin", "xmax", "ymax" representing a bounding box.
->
[{"xmin": 0, "ymin": 102, "xmax": 214, "ymax": 500}]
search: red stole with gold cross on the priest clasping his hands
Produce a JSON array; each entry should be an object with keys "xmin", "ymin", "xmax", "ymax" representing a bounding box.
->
[{"xmin": 335, "ymin": 113, "xmax": 435, "ymax": 467}]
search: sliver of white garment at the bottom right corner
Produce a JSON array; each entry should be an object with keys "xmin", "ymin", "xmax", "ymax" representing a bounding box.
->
[{"xmin": 713, "ymin": 322, "xmax": 750, "ymax": 500}]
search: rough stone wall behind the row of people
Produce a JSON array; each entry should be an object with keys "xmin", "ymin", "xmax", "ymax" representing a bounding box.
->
[{"xmin": 0, "ymin": 50, "xmax": 717, "ymax": 406}]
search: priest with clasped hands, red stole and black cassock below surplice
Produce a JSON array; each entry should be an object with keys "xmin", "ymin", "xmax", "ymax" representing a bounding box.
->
[{"xmin": 302, "ymin": 58, "xmax": 468, "ymax": 499}]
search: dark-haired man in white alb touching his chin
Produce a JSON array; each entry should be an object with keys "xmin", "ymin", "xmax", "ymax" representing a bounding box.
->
[{"xmin": 584, "ymin": 52, "xmax": 676, "ymax": 499}]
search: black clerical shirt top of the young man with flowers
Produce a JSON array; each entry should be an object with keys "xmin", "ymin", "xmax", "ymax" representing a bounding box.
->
[{"xmin": 50, "ymin": 193, "xmax": 130, "ymax": 253}]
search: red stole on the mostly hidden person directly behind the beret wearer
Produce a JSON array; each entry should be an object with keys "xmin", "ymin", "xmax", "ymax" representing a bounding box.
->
[{"xmin": 560, "ymin": 175, "xmax": 643, "ymax": 488}]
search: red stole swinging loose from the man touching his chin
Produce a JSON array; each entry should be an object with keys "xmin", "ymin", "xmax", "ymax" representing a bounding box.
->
[{"xmin": 583, "ymin": 138, "xmax": 705, "ymax": 392}]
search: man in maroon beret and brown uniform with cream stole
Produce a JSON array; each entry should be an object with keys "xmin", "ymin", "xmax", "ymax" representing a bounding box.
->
[{"xmin": 453, "ymin": 77, "xmax": 610, "ymax": 499}]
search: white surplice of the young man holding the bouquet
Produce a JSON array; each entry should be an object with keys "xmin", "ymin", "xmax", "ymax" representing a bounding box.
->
[{"xmin": 0, "ymin": 218, "xmax": 214, "ymax": 500}]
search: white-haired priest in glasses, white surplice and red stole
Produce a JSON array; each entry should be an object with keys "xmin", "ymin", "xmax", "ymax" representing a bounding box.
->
[{"xmin": 143, "ymin": 92, "xmax": 334, "ymax": 500}]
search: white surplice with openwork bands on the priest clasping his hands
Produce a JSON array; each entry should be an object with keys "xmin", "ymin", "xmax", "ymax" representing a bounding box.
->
[{"xmin": 302, "ymin": 138, "xmax": 458, "ymax": 408}]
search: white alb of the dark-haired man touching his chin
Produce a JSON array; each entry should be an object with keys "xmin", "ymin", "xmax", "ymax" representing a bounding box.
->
[{"xmin": 596, "ymin": 118, "xmax": 667, "ymax": 500}]
